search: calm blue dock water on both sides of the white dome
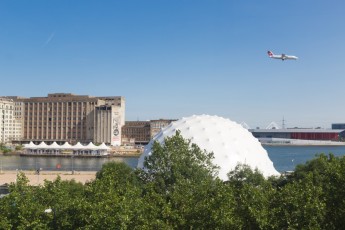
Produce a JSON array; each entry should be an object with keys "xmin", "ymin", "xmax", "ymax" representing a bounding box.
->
[{"xmin": 0, "ymin": 146, "xmax": 345, "ymax": 172}]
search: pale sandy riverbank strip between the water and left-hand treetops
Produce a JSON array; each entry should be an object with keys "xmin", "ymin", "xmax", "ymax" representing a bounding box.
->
[{"xmin": 0, "ymin": 170, "xmax": 96, "ymax": 185}]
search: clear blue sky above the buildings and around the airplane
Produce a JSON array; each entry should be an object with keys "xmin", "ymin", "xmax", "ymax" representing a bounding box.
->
[{"xmin": 0, "ymin": 0, "xmax": 345, "ymax": 128}]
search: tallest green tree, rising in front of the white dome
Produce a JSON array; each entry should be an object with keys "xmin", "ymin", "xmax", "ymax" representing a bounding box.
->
[{"xmin": 139, "ymin": 131, "xmax": 239, "ymax": 229}]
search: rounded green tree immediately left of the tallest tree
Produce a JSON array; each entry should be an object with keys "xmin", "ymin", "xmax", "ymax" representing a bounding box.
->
[{"xmin": 86, "ymin": 162, "xmax": 145, "ymax": 229}]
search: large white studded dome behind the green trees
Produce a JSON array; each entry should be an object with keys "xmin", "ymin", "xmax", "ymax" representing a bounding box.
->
[{"xmin": 138, "ymin": 115, "xmax": 279, "ymax": 180}]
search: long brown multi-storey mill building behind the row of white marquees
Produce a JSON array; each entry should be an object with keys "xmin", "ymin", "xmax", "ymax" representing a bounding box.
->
[{"xmin": 3, "ymin": 93, "xmax": 125, "ymax": 145}]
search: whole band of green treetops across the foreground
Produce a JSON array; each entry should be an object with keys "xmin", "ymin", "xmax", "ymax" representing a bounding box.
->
[{"xmin": 0, "ymin": 132, "xmax": 345, "ymax": 229}]
